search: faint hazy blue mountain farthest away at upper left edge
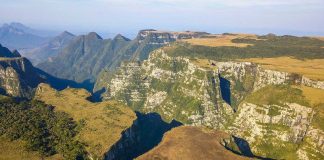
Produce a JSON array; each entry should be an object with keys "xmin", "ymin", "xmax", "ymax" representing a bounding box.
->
[{"xmin": 0, "ymin": 23, "xmax": 48, "ymax": 49}]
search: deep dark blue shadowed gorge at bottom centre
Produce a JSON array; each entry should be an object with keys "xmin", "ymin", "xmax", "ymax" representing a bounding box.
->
[{"xmin": 105, "ymin": 112, "xmax": 182, "ymax": 160}]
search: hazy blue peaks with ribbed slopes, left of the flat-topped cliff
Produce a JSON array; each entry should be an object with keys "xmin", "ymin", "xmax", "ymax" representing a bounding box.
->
[{"xmin": 37, "ymin": 32, "xmax": 130, "ymax": 83}]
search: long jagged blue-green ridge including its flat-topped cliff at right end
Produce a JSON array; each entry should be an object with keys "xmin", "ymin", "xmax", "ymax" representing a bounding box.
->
[{"xmin": 37, "ymin": 30, "xmax": 207, "ymax": 88}]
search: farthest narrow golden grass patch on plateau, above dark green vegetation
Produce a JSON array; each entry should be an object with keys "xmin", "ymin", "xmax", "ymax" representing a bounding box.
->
[{"xmin": 182, "ymin": 34, "xmax": 257, "ymax": 47}]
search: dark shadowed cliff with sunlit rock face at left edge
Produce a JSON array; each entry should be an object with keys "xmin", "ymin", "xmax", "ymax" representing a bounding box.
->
[{"xmin": 0, "ymin": 45, "xmax": 42, "ymax": 98}]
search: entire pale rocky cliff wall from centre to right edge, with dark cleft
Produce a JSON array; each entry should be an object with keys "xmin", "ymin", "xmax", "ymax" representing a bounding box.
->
[{"xmin": 98, "ymin": 48, "xmax": 324, "ymax": 159}]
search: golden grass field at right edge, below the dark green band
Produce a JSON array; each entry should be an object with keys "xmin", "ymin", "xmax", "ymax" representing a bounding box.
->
[{"xmin": 238, "ymin": 57, "xmax": 324, "ymax": 81}]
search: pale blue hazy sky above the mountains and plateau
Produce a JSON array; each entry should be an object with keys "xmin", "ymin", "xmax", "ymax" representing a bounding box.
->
[{"xmin": 0, "ymin": 0, "xmax": 324, "ymax": 36}]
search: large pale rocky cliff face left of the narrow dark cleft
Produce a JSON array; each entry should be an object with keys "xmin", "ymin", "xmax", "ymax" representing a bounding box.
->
[{"xmin": 104, "ymin": 50, "xmax": 231, "ymax": 126}]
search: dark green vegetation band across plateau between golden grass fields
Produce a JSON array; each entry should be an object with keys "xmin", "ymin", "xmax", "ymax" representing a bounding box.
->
[{"xmin": 168, "ymin": 35, "xmax": 324, "ymax": 61}]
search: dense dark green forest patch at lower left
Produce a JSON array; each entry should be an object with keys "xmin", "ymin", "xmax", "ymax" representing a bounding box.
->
[{"xmin": 0, "ymin": 98, "xmax": 86, "ymax": 159}]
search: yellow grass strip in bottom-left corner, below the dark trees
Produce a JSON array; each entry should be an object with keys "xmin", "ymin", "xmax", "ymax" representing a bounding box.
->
[{"xmin": 0, "ymin": 137, "xmax": 63, "ymax": 160}]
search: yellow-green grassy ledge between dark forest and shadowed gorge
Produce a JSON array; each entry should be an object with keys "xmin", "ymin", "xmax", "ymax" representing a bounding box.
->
[{"xmin": 36, "ymin": 84, "xmax": 136, "ymax": 157}]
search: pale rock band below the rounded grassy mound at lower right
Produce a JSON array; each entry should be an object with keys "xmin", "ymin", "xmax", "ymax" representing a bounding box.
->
[{"xmin": 234, "ymin": 103, "xmax": 313, "ymax": 143}]
